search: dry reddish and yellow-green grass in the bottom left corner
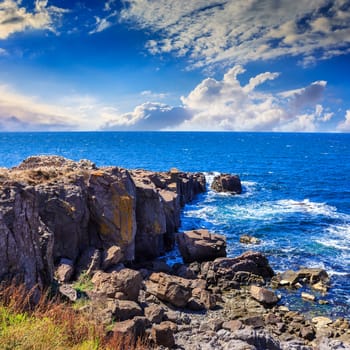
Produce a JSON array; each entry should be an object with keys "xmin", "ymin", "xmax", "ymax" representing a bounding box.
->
[{"xmin": 0, "ymin": 283, "xmax": 150, "ymax": 350}]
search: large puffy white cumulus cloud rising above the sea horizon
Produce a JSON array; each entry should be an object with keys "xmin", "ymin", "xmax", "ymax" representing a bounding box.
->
[{"xmin": 103, "ymin": 66, "xmax": 333, "ymax": 131}]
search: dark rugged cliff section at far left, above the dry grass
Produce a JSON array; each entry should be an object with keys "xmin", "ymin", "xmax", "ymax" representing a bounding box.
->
[{"xmin": 0, "ymin": 180, "xmax": 54, "ymax": 297}]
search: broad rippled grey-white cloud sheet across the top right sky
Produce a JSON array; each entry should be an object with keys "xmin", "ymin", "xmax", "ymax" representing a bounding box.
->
[{"xmin": 121, "ymin": 0, "xmax": 350, "ymax": 66}]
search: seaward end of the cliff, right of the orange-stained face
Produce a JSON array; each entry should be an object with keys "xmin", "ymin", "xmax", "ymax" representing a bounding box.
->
[{"xmin": 131, "ymin": 170, "xmax": 205, "ymax": 261}]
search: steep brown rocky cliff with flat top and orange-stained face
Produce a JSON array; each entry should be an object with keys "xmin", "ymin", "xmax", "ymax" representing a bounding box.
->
[{"xmin": 0, "ymin": 156, "xmax": 205, "ymax": 287}]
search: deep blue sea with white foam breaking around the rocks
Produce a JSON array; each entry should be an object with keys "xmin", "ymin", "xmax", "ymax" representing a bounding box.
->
[{"xmin": 0, "ymin": 132, "xmax": 350, "ymax": 317}]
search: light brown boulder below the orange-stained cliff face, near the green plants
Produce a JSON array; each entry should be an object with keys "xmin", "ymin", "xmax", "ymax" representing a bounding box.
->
[{"xmin": 92, "ymin": 268, "xmax": 142, "ymax": 301}]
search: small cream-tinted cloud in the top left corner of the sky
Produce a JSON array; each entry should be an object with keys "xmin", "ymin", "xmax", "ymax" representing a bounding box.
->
[{"xmin": 0, "ymin": 0, "xmax": 66, "ymax": 39}]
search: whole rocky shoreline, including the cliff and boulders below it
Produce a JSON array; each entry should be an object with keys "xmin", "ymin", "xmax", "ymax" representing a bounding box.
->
[{"xmin": 0, "ymin": 156, "xmax": 350, "ymax": 350}]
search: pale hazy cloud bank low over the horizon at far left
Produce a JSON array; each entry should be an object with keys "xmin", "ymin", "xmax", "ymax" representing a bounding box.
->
[{"xmin": 0, "ymin": 84, "xmax": 119, "ymax": 131}]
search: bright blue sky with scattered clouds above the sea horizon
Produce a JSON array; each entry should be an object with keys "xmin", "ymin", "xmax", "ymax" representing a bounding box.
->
[{"xmin": 0, "ymin": 0, "xmax": 350, "ymax": 132}]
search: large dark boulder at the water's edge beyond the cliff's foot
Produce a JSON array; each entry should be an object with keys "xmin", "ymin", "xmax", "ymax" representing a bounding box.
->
[{"xmin": 177, "ymin": 229, "xmax": 226, "ymax": 263}]
